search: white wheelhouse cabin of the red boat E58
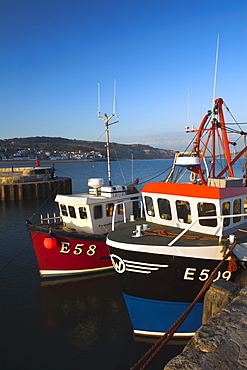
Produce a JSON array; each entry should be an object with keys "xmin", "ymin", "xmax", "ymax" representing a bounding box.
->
[{"xmin": 55, "ymin": 179, "xmax": 139, "ymax": 234}]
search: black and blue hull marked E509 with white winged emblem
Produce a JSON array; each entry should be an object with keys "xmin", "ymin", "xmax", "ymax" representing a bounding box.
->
[{"xmin": 107, "ymin": 234, "xmax": 235, "ymax": 337}]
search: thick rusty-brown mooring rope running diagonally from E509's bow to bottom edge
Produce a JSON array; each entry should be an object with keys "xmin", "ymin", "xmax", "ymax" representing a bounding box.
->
[{"xmin": 131, "ymin": 240, "xmax": 237, "ymax": 370}]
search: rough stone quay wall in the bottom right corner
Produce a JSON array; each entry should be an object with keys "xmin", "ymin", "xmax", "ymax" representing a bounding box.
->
[{"xmin": 164, "ymin": 286, "xmax": 247, "ymax": 370}]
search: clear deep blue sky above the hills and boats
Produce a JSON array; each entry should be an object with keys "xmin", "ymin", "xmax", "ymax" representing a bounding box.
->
[{"xmin": 0, "ymin": 0, "xmax": 247, "ymax": 150}]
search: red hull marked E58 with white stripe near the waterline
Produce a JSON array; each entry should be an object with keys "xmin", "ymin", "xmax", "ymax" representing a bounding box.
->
[{"xmin": 27, "ymin": 224, "xmax": 113, "ymax": 278}]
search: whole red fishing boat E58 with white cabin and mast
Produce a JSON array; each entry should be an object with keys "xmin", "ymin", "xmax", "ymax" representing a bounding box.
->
[{"xmin": 26, "ymin": 95, "xmax": 139, "ymax": 278}]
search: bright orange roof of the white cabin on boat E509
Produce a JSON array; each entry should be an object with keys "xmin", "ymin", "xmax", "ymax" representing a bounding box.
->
[{"xmin": 141, "ymin": 182, "xmax": 247, "ymax": 199}]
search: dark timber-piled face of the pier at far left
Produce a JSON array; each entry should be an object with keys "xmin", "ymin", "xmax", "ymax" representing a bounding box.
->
[{"xmin": 0, "ymin": 177, "xmax": 72, "ymax": 201}]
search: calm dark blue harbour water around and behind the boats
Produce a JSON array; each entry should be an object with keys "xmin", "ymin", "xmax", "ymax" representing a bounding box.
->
[{"xmin": 0, "ymin": 160, "xmax": 245, "ymax": 370}]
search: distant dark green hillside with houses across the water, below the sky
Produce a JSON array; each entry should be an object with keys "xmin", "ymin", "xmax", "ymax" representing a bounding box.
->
[{"xmin": 0, "ymin": 136, "xmax": 174, "ymax": 159}]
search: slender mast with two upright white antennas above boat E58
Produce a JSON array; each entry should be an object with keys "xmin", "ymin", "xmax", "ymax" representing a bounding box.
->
[{"xmin": 97, "ymin": 80, "xmax": 119, "ymax": 186}]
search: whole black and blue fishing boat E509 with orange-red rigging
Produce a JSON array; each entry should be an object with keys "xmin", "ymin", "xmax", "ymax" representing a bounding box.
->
[{"xmin": 107, "ymin": 98, "xmax": 247, "ymax": 337}]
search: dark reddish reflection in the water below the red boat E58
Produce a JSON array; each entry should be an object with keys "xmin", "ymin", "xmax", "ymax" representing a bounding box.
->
[{"xmin": 39, "ymin": 272, "xmax": 131, "ymax": 353}]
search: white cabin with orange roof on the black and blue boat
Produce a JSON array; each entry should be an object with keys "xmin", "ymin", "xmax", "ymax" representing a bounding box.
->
[{"xmin": 142, "ymin": 178, "xmax": 247, "ymax": 236}]
